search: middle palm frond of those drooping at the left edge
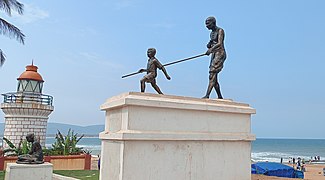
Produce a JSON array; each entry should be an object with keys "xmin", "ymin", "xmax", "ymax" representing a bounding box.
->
[{"xmin": 0, "ymin": 18, "xmax": 25, "ymax": 44}]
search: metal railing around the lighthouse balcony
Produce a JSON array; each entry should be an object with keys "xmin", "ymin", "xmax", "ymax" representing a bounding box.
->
[{"xmin": 2, "ymin": 92, "xmax": 53, "ymax": 106}]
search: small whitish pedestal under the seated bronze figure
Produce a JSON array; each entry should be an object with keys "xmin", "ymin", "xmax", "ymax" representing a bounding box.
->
[{"xmin": 5, "ymin": 163, "xmax": 53, "ymax": 180}]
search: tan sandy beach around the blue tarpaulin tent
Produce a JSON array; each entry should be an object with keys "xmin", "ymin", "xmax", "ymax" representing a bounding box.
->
[{"xmin": 252, "ymin": 164, "xmax": 325, "ymax": 180}]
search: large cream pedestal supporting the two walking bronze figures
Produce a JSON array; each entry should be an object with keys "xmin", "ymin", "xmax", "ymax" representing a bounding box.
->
[{"xmin": 100, "ymin": 93, "xmax": 255, "ymax": 180}]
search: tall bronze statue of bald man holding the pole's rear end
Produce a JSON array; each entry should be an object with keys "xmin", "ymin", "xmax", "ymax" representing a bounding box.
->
[{"xmin": 203, "ymin": 17, "xmax": 227, "ymax": 99}]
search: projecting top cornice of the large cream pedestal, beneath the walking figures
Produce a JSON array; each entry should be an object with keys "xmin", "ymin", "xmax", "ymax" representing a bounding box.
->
[{"xmin": 100, "ymin": 92, "xmax": 256, "ymax": 114}]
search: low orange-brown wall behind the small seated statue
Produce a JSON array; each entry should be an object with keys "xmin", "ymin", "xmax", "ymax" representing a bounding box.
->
[{"xmin": 0, "ymin": 154, "xmax": 91, "ymax": 171}]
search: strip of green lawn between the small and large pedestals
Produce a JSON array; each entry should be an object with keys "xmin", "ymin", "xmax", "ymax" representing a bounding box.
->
[{"xmin": 53, "ymin": 170, "xmax": 99, "ymax": 180}]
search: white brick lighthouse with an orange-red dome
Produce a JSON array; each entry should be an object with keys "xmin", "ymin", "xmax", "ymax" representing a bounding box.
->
[{"xmin": 1, "ymin": 63, "xmax": 54, "ymax": 147}]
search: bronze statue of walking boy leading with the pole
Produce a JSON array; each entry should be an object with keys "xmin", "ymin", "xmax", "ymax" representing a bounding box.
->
[{"xmin": 138, "ymin": 48, "xmax": 171, "ymax": 94}]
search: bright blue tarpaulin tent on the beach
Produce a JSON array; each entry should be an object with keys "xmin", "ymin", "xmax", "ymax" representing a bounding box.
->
[{"xmin": 251, "ymin": 162, "xmax": 297, "ymax": 178}]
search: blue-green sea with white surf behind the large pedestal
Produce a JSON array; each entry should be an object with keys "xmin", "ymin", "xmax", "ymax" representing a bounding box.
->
[{"xmin": 2, "ymin": 137, "xmax": 325, "ymax": 162}]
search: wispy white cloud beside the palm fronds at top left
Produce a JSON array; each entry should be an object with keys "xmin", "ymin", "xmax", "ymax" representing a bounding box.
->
[{"xmin": 12, "ymin": 4, "xmax": 50, "ymax": 24}]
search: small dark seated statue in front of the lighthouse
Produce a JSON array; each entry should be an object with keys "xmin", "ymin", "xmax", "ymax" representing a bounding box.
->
[{"xmin": 16, "ymin": 133, "xmax": 44, "ymax": 164}]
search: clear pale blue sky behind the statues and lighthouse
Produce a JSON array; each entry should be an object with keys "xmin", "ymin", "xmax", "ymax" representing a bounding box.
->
[{"xmin": 0, "ymin": 0, "xmax": 325, "ymax": 138}]
